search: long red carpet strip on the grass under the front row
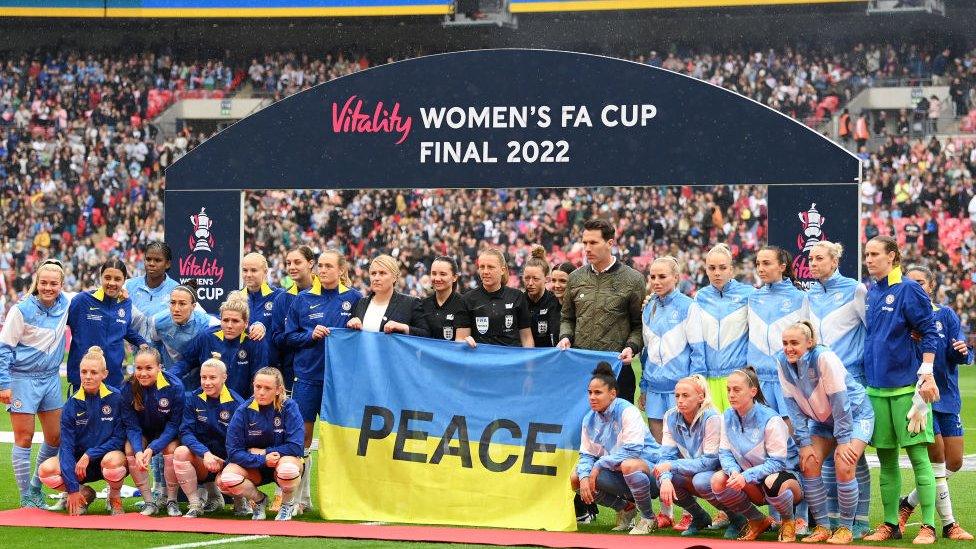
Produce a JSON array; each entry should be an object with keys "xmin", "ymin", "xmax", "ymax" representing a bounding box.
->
[{"xmin": 0, "ymin": 509, "xmax": 856, "ymax": 549}]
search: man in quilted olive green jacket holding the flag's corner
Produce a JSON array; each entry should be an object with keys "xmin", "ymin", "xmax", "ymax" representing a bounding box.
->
[{"xmin": 557, "ymin": 219, "xmax": 647, "ymax": 402}]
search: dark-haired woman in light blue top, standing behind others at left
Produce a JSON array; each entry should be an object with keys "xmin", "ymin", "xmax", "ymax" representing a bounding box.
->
[{"xmin": 125, "ymin": 240, "xmax": 178, "ymax": 339}]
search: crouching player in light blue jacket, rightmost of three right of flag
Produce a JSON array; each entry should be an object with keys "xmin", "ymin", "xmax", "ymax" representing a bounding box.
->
[{"xmin": 712, "ymin": 367, "xmax": 803, "ymax": 542}]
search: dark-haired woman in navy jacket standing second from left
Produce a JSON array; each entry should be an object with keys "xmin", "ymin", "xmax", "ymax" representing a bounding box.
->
[{"xmin": 67, "ymin": 258, "xmax": 149, "ymax": 392}]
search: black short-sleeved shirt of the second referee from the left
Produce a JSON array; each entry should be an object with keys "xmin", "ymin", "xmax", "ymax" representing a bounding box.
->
[{"xmin": 455, "ymin": 286, "xmax": 530, "ymax": 347}]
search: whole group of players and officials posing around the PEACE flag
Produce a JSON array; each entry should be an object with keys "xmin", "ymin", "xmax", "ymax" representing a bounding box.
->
[{"xmin": 0, "ymin": 220, "xmax": 971, "ymax": 543}]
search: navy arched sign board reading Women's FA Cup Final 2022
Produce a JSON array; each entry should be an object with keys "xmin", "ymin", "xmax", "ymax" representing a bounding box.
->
[{"xmin": 166, "ymin": 50, "xmax": 860, "ymax": 310}]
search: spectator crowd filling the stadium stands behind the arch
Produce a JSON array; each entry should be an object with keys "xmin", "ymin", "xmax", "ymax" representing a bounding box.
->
[{"xmin": 0, "ymin": 44, "xmax": 976, "ymax": 326}]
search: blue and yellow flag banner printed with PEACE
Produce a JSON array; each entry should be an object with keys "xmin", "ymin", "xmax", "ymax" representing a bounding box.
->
[{"xmin": 317, "ymin": 330, "xmax": 619, "ymax": 531}]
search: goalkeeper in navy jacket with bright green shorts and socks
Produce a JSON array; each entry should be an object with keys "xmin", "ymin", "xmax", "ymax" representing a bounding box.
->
[{"xmin": 864, "ymin": 236, "xmax": 939, "ymax": 544}]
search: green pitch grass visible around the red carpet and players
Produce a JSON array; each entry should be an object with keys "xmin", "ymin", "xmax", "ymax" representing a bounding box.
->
[{"xmin": 0, "ymin": 367, "xmax": 976, "ymax": 549}]
